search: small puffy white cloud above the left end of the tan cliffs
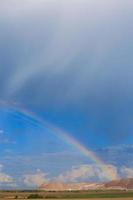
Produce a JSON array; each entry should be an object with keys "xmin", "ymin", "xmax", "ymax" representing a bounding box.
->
[{"xmin": 24, "ymin": 170, "xmax": 48, "ymax": 187}]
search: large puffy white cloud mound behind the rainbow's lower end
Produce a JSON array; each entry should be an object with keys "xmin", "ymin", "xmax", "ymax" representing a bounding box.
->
[{"xmin": 56, "ymin": 164, "xmax": 118, "ymax": 182}]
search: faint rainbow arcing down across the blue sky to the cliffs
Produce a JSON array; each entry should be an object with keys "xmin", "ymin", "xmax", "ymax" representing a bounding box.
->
[{"xmin": 0, "ymin": 102, "xmax": 116, "ymax": 180}]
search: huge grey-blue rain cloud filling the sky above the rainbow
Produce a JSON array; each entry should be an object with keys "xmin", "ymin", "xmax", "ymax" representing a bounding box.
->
[{"xmin": 0, "ymin": 0, "xmax": 133, "ymax": 143}]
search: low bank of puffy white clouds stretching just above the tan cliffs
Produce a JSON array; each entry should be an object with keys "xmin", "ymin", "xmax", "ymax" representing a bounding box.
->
[{"xmin": 24, "ymin": 165, "xmax": 133, "ymax": 187}]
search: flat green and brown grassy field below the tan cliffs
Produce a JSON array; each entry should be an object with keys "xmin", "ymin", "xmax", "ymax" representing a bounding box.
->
[{"xmin": 0, "ymin": 191, "xmax": 133, "ymax": 200}]
